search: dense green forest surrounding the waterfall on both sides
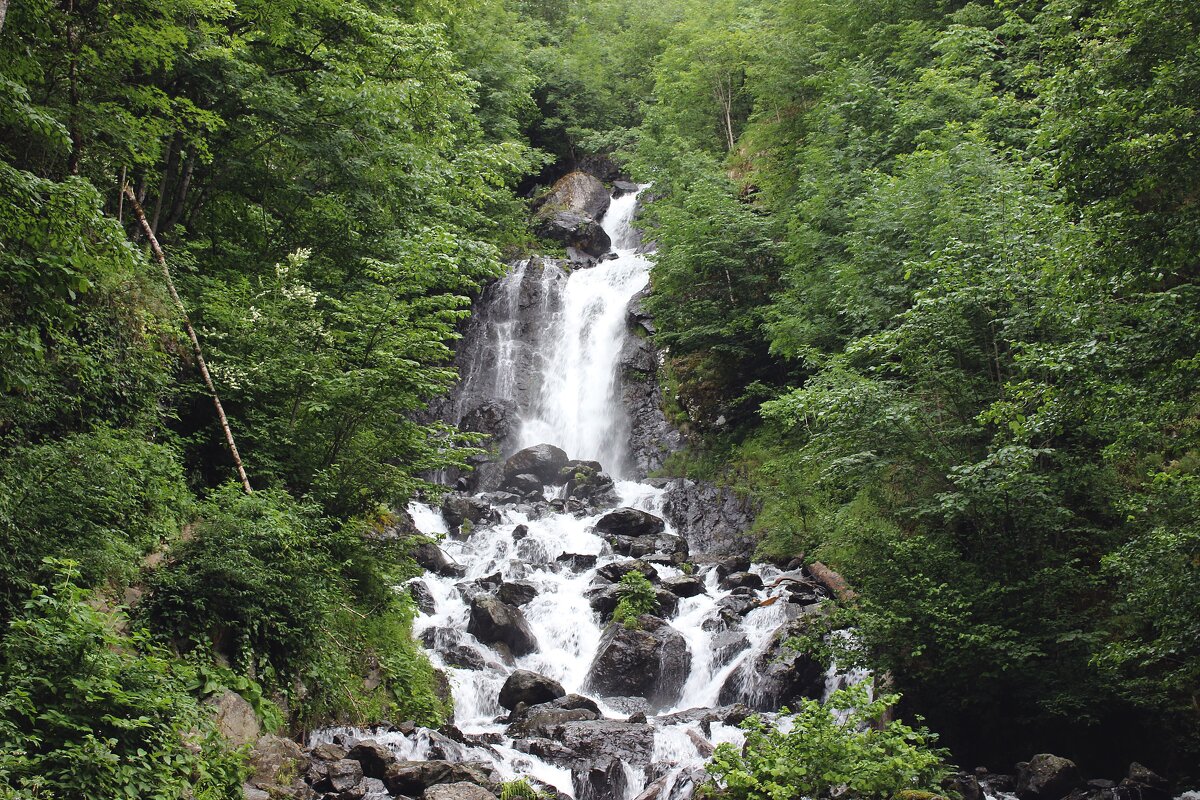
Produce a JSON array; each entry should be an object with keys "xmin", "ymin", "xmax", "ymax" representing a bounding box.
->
[{"xmin": 0, "ymin": 0, "xmax": 1200, "ymax": 800}]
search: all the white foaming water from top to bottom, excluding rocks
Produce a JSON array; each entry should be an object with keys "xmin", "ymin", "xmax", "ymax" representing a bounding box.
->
[{"xmin": 313, "ymin": 184, "xmax": 860, "ymax": 800}]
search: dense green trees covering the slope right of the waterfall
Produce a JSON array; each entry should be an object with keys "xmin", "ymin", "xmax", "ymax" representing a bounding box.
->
[{"xmin": 631, "ymin": 0, "xmax": 1200, "ymax": 763}]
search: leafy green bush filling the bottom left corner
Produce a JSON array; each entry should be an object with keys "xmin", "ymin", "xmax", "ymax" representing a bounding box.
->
[{"xmin": 0, "ymin": 563, "xmax": 241, "ymax": 800}]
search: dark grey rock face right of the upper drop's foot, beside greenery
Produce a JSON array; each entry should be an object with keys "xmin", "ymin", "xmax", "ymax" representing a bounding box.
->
[{"xmin": 662, "ymin": 479, "xmax": 756, "ymax": 555}]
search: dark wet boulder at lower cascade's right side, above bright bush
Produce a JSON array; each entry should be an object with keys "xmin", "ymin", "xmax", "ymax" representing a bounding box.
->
[{"xmin": 718, "ymin": 620, "xmax": 824, "ymax": 711}]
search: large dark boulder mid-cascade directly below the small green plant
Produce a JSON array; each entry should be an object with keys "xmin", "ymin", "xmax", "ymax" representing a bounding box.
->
[{"xmin": 584, "ymin": 614, "xmax": 691, "ymax": 709}]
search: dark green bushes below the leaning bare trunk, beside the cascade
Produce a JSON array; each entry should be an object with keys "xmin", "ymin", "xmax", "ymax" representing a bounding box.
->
[{"xmin": 140, "ymin": 485, "xmax": 445, "ymax": 722}]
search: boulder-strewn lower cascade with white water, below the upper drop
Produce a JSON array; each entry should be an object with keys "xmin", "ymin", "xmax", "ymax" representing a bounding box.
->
[{"xmin": 300, "ymin": 445, "xmax": 856, "ymax": 800}]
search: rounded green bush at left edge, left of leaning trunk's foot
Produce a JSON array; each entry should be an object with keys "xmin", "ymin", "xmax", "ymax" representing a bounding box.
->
[{"xmin": 0, "ymin": 428, "xmax": 191, "ymax": 620}]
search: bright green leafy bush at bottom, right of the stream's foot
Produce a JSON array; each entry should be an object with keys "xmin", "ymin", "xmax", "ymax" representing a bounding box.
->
[{"xmin": 707, "ymin": 684, "xmax": 947, "ymax": 800}]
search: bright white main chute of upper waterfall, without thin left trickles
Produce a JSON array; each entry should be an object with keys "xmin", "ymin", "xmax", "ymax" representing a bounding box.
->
[{"xmin": 520, "ymin": 193, "xmax": 650, "ymax": 476}]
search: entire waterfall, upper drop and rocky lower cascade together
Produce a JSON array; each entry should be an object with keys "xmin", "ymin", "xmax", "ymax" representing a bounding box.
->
[{"xmin": 311, "ymin": 187, "xmax": 862, "ymax": 800}]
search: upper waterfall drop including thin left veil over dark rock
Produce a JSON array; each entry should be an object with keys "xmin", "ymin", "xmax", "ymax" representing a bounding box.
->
[{"xmin": 439, "ymin": 186, "xmax": 679, "ymax": 482}]
